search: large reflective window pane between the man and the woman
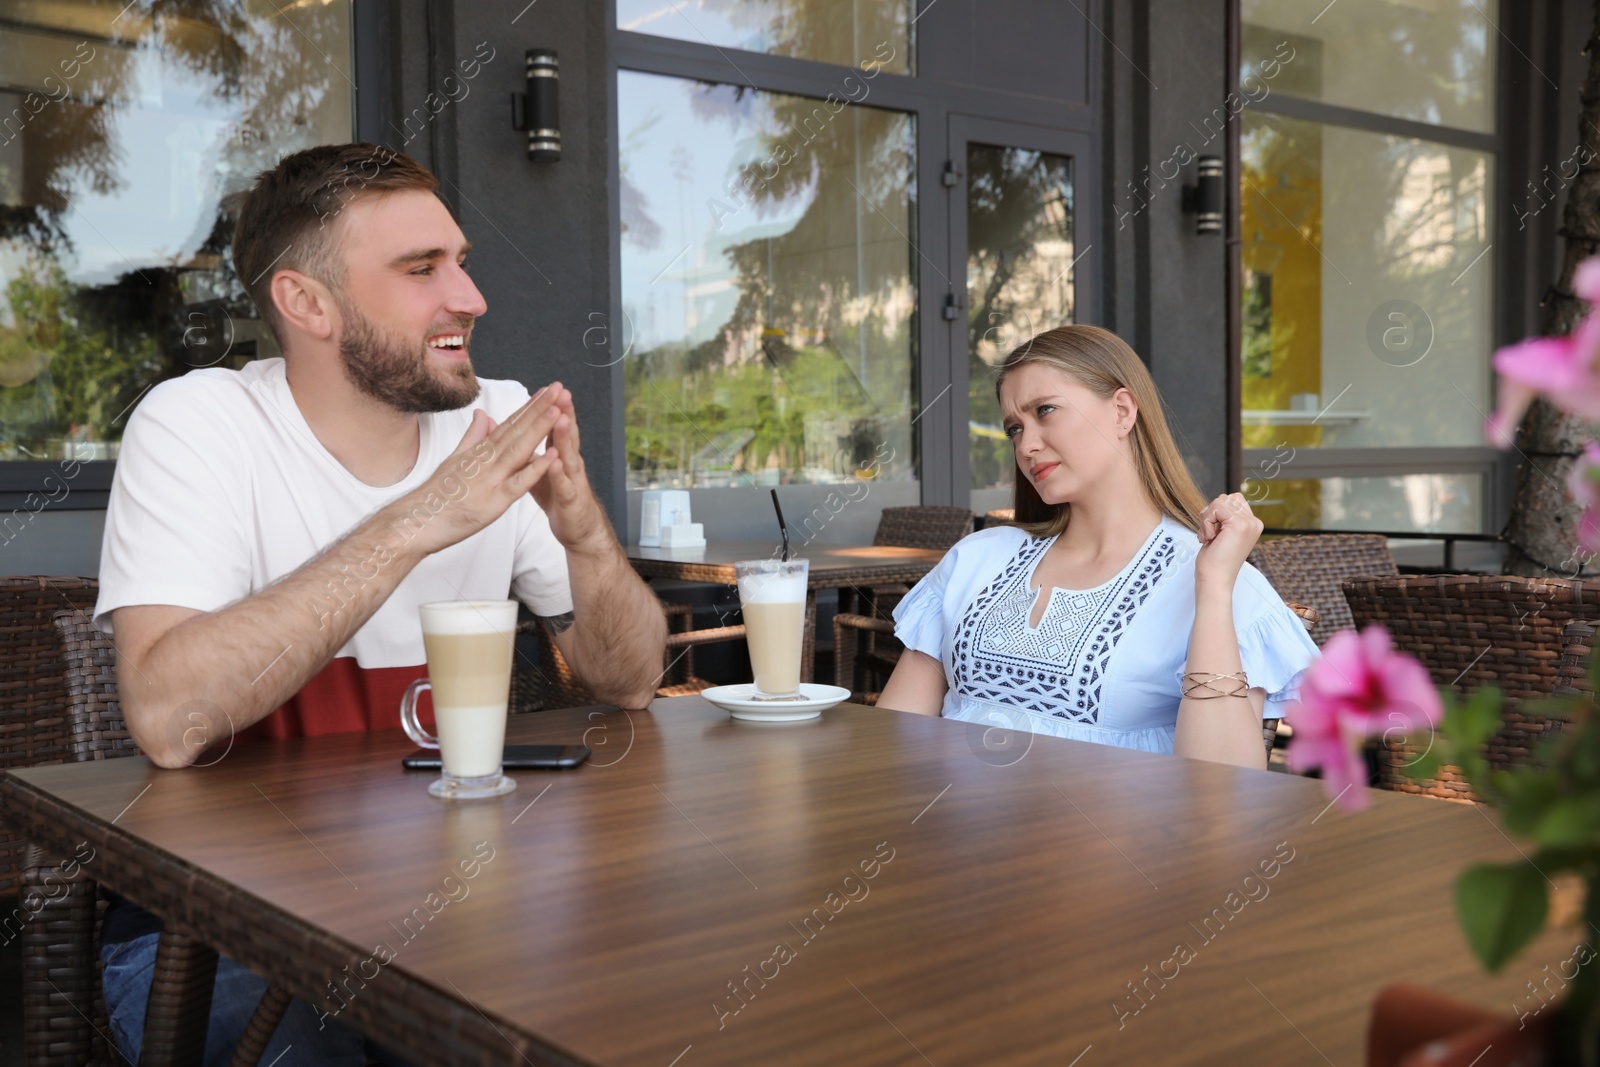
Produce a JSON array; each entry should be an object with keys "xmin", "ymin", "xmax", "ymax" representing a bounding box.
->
[{"xmin": 618, "ymin": 70, "xmax": 917, "ymax": 490}]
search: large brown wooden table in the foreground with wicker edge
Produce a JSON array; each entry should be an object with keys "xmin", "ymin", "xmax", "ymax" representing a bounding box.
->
[{"xmin": 0, "ymin": 697, "xmax": 1579, "ymax": 1067}]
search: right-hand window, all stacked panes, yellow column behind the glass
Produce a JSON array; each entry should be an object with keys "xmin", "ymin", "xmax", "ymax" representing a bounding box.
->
[{"xmin": 1235, "ymin": 0, "xmax": 1499, "ymax": 533}]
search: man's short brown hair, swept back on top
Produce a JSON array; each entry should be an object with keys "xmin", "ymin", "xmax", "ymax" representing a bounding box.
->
[{"xmin": 234, "ymin": 142, "xmax": 438, "ymax": 346}]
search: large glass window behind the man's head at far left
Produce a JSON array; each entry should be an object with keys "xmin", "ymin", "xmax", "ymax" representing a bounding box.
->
[{"xmin": 0, "ymin": 0, "xmax": 355, "ymax": 459}]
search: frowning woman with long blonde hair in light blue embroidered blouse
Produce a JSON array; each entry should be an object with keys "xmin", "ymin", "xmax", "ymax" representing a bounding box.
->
[{"xmin": 878, "ymin": 326, "xmax": 1317, "ymax": 768}]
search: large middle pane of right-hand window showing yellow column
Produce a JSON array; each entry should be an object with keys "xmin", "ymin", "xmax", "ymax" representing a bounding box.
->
[{"xmin": 1240, "ymin": 110, "xmax": 1494, "ymax": 448}]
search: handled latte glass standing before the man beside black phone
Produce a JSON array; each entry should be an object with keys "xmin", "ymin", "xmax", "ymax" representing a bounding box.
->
[{"xmin": 400, "ymin": 600, "xmax": 517, "ymax": 800}]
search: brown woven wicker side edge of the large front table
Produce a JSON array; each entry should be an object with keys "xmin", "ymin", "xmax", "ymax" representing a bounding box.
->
[{"xmin": 0, "ymin": 767, "xmax": 597, "ymax": 1067}]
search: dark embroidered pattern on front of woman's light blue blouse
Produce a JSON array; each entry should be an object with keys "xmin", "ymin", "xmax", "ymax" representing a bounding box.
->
[{"xmin": 952, "ymin": 533, "xmax": 1178, "ymax": 723}]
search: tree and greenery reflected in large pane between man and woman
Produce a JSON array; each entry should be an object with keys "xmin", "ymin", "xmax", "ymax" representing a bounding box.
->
[{"xmin": 624, "ymin": 85, "xmax": 917, "ymax": 485}]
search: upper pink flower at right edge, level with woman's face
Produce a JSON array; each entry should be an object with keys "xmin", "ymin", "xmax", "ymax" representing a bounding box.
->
[{"xmin": 1483, "ymin": 258, "xmax": 1600, "ymax": 448}]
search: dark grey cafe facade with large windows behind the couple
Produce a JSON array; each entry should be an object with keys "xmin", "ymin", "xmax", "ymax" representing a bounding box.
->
[{"xmin": 0, "ymin": 0, "xmax": 1590, "ymax": 576}]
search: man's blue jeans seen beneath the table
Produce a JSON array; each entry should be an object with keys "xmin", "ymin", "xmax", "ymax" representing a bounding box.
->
[{"xmin": 101, "ymin": 934, "xmax": 403, "ymax": 1067}]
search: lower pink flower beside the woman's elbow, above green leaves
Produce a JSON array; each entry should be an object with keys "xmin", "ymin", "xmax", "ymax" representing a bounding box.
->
[{"xmin": 1286, "ymin": 625, "xmax": 1445, "ymax": 811}]
